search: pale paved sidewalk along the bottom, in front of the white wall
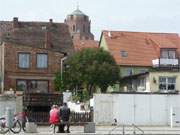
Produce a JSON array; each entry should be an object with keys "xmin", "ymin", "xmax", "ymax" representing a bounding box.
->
[{"xmin": 4, "ymin": 126, "xmax": 180, "ymax": 135}]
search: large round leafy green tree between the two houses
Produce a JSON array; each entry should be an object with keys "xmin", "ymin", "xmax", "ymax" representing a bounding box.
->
[{"xmin": 54, "ymin": 48, "xmax": 119, "ymax": 96}]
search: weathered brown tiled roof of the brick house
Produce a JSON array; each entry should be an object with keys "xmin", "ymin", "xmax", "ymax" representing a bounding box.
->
[{"xmin": 0, "ymin": 21, "xmax": 74, "ymax": 53}]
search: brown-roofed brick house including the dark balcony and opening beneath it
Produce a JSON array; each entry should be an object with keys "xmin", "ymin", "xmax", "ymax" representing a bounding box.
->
[{"xmin": 0, "ymin": 17, "xmax": 74, "ymax": 119}]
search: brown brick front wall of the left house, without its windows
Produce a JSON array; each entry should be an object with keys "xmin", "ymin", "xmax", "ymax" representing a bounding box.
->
[{"xmin": 5, "ymin": 43, "xmax": 63, "ymax": 91}]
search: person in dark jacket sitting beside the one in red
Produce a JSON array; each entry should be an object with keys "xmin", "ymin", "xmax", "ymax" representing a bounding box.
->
[{"xmin": 59, "ymin": 103, "xmax": 71, "ymax": 133}]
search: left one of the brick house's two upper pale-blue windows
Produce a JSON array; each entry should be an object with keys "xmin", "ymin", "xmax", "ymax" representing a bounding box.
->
[{"xmin": 18, "ymin": 53, "xmax": 30, "ymax": 68}]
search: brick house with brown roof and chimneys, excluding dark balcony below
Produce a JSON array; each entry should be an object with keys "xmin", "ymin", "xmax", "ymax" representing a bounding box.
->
[{"xmin": 0, "ymin": 18, "xmax": 74, "ymax": 93}]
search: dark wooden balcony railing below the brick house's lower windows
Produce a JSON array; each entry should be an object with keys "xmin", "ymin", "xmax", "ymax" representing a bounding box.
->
[{"xmin": 23, "ymin": 93, "xmax": 62, "ymax": 106}]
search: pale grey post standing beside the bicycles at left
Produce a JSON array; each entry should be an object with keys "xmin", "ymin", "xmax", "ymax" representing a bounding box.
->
[{"xmin": 6, "ymin": 107, "xmax": 14, "ymax": 128}]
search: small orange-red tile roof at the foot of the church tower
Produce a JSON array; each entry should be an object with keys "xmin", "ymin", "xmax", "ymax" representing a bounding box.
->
[{"xmin": 73, "ymin": 40, "xmax": 99, "ymax": 51}]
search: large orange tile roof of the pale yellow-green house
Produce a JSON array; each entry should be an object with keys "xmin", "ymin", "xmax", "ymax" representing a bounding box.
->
[{"xmin": 100, "ymin": 31, "xmax": 180, "ymax": 66}]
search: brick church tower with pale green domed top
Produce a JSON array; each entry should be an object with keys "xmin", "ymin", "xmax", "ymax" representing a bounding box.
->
[{"xmin": 65, "ymin": 7, "xmax": 94, "ymax": 40}]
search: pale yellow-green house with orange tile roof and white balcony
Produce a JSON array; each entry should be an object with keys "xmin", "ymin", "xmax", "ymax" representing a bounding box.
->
[{"xmin": 100, "ymin": 31, "xmax": 180, "ymax": 92}]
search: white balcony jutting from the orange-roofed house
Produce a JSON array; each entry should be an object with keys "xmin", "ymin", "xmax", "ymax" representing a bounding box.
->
[{"xmin": 152, "ymin": 58, "xmax": 179, "ymax": 68}]
